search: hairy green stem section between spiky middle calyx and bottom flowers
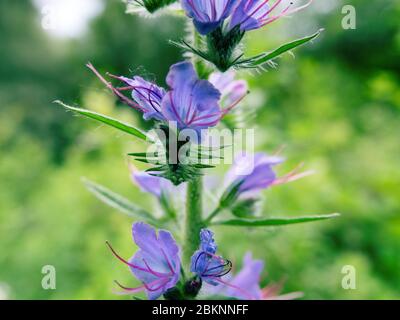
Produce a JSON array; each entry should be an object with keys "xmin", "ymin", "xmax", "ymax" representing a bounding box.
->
[{"xmin": 183, "ymin": 177, "xmax": 203, "ymax": 267}]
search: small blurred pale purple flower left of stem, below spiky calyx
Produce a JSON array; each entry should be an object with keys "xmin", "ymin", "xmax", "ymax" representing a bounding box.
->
[{"xmin": 131, "ymin": 169, "xmax": 173, "ymax": 198}]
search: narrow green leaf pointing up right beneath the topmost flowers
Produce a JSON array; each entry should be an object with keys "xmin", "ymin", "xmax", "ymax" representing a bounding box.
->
[{"xmin": 236, "ymin": 29, "xmax": 323, "ymax": 68}]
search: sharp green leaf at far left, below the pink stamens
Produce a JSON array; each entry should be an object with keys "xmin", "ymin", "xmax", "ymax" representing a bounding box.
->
[{"xmin": 55, "ymin": 101, "xmax": 152, "ymax": 141}]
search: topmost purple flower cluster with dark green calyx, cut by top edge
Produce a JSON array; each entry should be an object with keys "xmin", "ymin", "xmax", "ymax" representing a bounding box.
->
[{"xmin": 177, "ymin": 0, "xmax": 312, "ymax": 72}]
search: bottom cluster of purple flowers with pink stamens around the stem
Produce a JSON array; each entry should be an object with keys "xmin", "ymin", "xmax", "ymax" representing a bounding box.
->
[{"xmin": 107, "ymin": 222, "xmax": 301, "ymax": 300}]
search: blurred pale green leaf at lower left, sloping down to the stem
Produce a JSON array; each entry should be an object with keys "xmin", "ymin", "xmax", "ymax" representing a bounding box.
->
[{"xmin": 82, "ymin": 178, "xmax": 158, "ymax": 225}]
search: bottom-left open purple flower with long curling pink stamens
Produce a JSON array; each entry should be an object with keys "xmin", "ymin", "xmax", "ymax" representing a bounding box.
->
[{"xmin": 107, "ymin": 222, "xmax": 180, "ymax": 300}]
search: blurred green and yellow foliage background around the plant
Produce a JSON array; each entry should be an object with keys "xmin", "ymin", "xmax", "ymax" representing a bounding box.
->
[{"xmin": 0, "ymin": 0, "xmax": 400, "ymax": 299}]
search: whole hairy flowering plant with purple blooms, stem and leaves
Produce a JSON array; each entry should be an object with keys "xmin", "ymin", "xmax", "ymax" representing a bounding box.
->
[{"xmin": 60, "ymin": 0, "xmax": 337, "ymax": 300}]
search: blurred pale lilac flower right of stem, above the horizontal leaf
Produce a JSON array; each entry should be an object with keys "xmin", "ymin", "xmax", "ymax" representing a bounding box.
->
[{"xmin": 226, "ymin": 153, "xmax": 283, "ymax": 194}]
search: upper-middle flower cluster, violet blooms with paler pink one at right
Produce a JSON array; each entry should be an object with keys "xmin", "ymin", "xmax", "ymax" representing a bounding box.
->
[{"xmin": 87, "ymin": 61, "xmax": 247, "ymax": 133}]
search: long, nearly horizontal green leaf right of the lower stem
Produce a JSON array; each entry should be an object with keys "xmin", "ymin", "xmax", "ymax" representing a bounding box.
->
[{"xmin": 212, "ymin": 213, "xmax": 340, "ymax": 227}]
